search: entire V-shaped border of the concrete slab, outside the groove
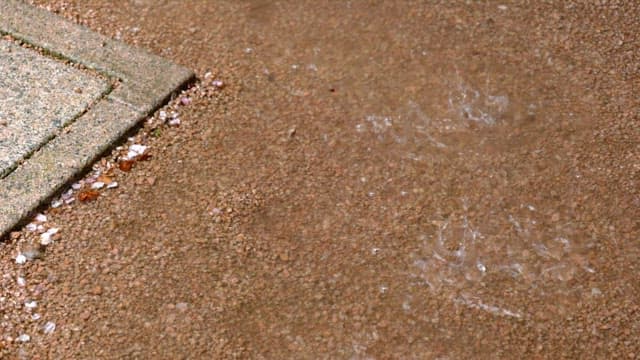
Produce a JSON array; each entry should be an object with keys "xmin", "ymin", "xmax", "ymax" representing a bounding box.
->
[{"xmin": 0, "ymin": 0, "xmax": 195, "ymax": 240}]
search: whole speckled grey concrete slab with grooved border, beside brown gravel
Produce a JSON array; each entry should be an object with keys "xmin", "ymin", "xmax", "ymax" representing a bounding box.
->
[{"xmin": 0, "ymin": 0, "xmax": 194, "ymax": 237}]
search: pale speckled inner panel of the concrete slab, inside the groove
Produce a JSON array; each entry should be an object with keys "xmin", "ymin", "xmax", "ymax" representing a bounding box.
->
[{"xmin": 0, "ymin": 40, "xmax": 109, "ymax": 178}]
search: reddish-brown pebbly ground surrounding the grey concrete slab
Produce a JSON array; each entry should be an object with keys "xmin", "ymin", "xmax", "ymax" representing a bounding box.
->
[{"xmin": 3, "ymin": 0, "xmax": 640, "ymax": 359}]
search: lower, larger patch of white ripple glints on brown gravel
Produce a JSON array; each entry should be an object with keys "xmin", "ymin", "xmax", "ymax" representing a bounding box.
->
[{"xmin": 410, "ymin": 201, "xmax": 597, "ymax": 317}]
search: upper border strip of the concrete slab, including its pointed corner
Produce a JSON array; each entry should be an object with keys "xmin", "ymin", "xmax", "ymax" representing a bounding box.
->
[{"xmin": 0, "ymin": 0, "xmax": 193, "ymax": 113}]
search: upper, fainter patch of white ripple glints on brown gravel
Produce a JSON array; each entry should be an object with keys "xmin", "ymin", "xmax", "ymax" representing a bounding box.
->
[{"xmin": 355, "ymin": 75, "xmax": 539, "ymax": 161}]
